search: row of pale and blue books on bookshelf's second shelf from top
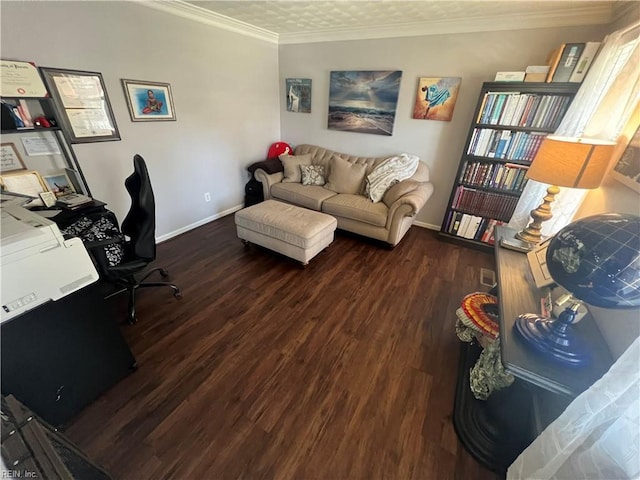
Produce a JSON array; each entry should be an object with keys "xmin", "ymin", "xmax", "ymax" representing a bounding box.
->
[{"xmin": 467, "ymin": 128, "xmax": 547, "ymax": 163}]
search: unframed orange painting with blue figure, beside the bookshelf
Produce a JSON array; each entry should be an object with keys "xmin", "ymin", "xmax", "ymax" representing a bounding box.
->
[{"xmin": 413, "ymin": 77, "xmax": 462, "ymax": 122}]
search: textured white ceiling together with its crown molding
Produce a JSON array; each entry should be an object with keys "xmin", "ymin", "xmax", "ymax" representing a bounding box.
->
[{"xmin": 145, "ymin": 0, "xmax": 640, "ymax": 43}]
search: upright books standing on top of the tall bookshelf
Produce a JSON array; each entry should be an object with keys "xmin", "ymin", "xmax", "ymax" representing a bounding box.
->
[{"xmin": 546, "ymin": 42, "xmax": 601, "ymax": 83}]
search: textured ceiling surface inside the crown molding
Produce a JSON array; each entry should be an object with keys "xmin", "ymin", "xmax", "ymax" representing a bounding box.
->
[{"xmin": 187, "ymin": 0, "xmax": 628, "ymax": 34}]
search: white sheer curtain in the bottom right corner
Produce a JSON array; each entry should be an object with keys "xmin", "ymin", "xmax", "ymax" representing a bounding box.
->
[{"xmin": 507, "ymin": 337, "xmax": 640, "ymax": 480}]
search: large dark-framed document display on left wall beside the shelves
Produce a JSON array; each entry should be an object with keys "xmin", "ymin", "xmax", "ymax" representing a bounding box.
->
[{"xmin": 40, "ymin": 67, "xmax": 120, "ymax": 143}]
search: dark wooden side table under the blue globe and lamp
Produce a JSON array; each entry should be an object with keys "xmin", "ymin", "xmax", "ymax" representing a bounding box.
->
[{"xmin": 453, "ymin": 227, "xmax": 613, "ymax": 473}]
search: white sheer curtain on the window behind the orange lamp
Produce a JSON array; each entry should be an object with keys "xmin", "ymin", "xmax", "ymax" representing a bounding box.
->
[{"xmin": 509, "ymin": 24, "xmax": 640, "ymax": 236}]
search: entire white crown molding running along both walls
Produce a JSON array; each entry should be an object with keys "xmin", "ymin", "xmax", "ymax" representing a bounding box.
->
[{"xmin": 136, "ymin": 0, "xmax": 613, "ymax": 45}]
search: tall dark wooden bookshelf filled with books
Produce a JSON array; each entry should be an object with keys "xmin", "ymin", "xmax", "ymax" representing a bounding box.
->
[{"xmin": 440, "ymin": 82, "xmax": 580, "ymax": 249}]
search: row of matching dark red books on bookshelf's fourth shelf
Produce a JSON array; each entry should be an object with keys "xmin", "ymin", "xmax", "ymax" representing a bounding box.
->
[{"xmin": 451, "ymin": 185, "xmax": 518, "ymax": 220}]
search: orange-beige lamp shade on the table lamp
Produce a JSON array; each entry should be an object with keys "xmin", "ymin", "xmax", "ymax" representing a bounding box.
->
[{"xmin": 527, "ymin": 135, "xmax": 616, "ymax": 188}]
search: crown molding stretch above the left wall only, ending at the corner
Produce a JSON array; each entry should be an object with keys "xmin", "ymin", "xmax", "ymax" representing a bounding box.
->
[{"xmin": 135, "ymin": 0, "xmax": 278, "ymax": 44}]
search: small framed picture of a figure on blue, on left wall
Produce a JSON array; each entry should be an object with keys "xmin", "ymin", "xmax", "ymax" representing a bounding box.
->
[{"xmin": 122, "ymin": 78, "xmax": 176, "ymax": 122}]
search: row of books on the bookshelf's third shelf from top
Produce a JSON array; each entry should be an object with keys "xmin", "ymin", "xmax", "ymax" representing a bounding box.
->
[{"xmin": 458, "ymin": 162, "xmax": 529, "ymax": 192}]
